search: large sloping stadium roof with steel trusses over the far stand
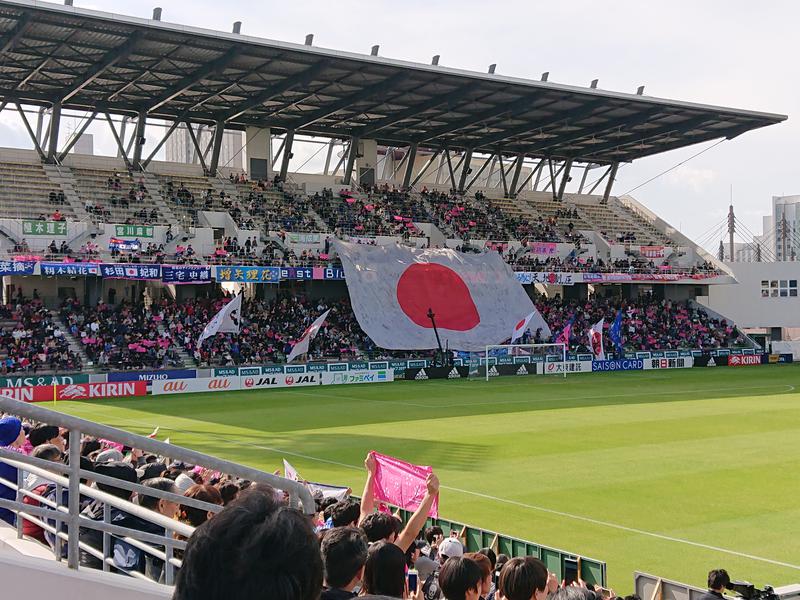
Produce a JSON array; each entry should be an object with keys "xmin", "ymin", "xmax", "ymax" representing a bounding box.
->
[{"xmin": 0, "ymin": 0, "xmax": 786, "ymax": 163}]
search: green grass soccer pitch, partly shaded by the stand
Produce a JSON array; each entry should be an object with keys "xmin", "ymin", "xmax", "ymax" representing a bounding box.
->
[{"xmin": 50, "ymin": 365, "xmax": 800, "ymax": 593}]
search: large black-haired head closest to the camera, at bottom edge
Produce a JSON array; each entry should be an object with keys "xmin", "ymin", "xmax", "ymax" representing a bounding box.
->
[{"xmin": 173, "ymin": 490, "xmax": 322, "ymax": 600}]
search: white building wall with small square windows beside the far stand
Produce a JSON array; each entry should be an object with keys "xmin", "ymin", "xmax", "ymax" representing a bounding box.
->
[{"xmin": 697, "ymin": 262, "xmax": 800, "ymax": 328}]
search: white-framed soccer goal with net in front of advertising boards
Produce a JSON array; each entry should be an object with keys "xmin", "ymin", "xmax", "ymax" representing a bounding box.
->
[{"xmin": 478, "ymin": 343, "xmax": 567, "ymax": 381}]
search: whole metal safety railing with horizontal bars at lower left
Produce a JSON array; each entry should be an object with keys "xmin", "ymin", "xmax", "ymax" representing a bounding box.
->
[{"xmin": 0, "ymin": 397, "xmax": 315, "ymax": 585}]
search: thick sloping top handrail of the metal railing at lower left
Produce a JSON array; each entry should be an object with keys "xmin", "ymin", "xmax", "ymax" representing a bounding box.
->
[{"xmin": 0, "ymin": 397, "xmax": 316, "ymax": 515}]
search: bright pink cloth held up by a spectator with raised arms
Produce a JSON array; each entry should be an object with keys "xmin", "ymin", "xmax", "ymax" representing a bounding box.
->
[{"xmin": 372, "ymin": 452, "xmax": 439, "ymax": 518}]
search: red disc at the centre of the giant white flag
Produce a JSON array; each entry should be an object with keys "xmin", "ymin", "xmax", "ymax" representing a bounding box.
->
[{"xmin": 397, "ymin": 263, "xmax": 481, "ymax": 331}]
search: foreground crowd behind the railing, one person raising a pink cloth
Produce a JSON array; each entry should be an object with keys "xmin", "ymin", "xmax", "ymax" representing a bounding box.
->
[{"xmin": 0, "ymin": 415, "xmax": 656, "ymax": 600}]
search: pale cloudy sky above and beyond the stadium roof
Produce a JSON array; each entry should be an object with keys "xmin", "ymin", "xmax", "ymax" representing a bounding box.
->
[{"xmin": 0, "ymin": 0, "xmax": 800, "ymax": 247}]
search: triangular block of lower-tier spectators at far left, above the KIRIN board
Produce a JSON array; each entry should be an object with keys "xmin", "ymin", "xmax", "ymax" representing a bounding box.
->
[{"xmin": 0, "ymin": 290, "xmax": 81, "ymax": 375}]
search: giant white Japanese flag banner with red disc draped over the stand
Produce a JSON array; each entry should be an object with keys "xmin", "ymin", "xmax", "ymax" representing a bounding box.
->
[{"xmin": 335, "ymin": 241, "xmax": 536, "ymax": 352}]
